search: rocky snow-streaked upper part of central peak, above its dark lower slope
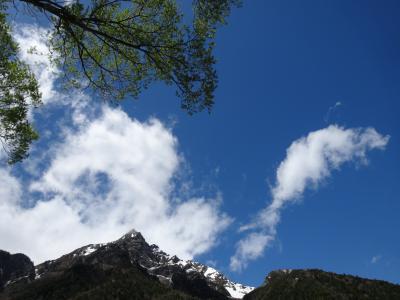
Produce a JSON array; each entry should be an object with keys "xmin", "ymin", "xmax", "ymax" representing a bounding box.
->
[{"xmin": 0, "ymin": 230, "xmax": 253, "ymax": 299}]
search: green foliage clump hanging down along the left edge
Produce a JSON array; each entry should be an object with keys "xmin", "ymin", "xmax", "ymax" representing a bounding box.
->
[{"xmin": 0, "ymin": 3, "xmax": 40, "ymax": 163}]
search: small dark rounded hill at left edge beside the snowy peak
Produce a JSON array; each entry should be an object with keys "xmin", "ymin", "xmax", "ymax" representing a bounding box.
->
[{"xmin": 0, "ymin": 250, "xmax": 35, "ymax": 291}]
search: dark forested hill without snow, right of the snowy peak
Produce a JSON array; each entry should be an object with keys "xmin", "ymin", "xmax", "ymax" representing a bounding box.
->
[{"xmin": 243, "ymin": 269, "xmax": 400, "ymax": 300}]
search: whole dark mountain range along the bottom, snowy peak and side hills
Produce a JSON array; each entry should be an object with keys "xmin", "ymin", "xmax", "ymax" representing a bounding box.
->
[{"xmin": 0, "ymin": 230, "xmax": 400, "ymax": 300}]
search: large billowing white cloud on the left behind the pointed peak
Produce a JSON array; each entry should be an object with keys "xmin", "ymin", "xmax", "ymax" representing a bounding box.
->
[{"xmin": 0, "ymin": 25, "xmax": 231, "ymax": 263}]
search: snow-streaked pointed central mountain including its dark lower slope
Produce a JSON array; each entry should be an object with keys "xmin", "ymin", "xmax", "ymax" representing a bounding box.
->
[{"xmin": 0, "ymin": 230, "xmax": 253, "ymax": 300}]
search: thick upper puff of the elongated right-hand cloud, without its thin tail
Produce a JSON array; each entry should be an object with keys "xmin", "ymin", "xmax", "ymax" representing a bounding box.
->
[{"xmin": 271, "ymin": 125, "xmax": 389, "ymax": 209}]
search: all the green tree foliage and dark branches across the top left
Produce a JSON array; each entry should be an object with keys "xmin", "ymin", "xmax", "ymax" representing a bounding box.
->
[{"xmin": 0, "ymin": 0, "xmax": 240, "ymax": 162}]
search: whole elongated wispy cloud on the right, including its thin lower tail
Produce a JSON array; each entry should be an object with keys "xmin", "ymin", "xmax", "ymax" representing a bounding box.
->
[{"xmin": 231, "ymin": 125, "xmax": 389, "ymax": 270}]
